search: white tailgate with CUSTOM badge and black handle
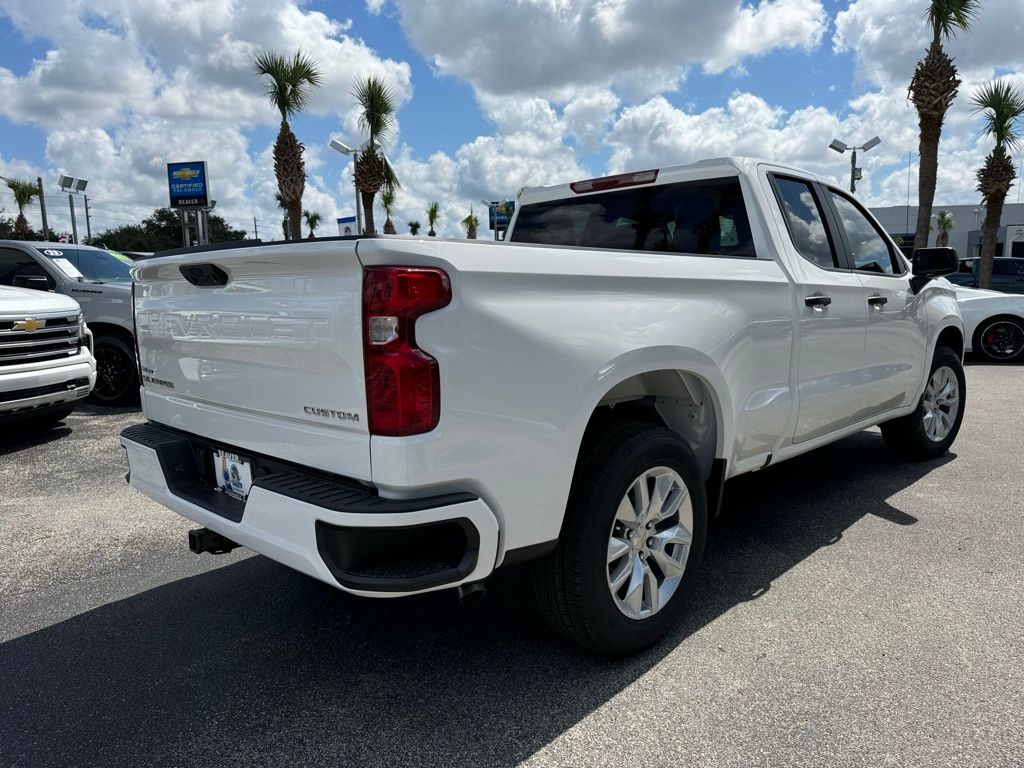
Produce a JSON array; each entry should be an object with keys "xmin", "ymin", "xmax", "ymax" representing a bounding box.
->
[{"xmin": 134, "ymin": 241, "xmax": 370, "ymax": 480}]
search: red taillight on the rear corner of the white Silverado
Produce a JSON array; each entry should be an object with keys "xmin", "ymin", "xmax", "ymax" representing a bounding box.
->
[{"xmin": 362, "ymin": 266, "xmax": 452, "ymax": 435}]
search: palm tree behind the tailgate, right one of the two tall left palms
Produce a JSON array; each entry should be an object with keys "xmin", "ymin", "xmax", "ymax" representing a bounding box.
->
[{"xmin": 352, "ymin": 76, "xmax": 400, "ymax": 234}]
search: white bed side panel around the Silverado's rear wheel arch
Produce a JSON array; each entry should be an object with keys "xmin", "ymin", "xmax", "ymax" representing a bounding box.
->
[{"xmin": 357, "ymin": 239, "xmax": 794, "ymax": 549}]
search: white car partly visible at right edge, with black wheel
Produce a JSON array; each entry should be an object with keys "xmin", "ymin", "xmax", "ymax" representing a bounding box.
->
[{"xmin": 955, "ymin": 286, "xmax": 1024, "ymax": 362}]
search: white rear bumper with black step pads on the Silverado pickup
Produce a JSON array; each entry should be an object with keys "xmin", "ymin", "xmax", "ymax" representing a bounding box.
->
[{"xmin": 121, "ymin": 424, "xmax": 499, "ymax": 597}]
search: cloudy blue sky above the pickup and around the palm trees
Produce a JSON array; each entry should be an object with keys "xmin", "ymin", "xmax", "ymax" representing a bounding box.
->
[{"xmin": 0, "ymin": 0, "xmax": 1024, "ymax": 234}]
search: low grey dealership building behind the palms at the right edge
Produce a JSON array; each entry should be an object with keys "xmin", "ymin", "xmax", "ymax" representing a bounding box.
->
[{"xmin": 871, "ymin": 203, "xmax": 1024, "ymax": 259}]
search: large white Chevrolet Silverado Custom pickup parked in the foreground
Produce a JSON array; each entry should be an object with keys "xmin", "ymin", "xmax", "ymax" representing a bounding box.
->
[{"xmin": 121, "ymin": 159, "xmax": 965, "ymax": 653}]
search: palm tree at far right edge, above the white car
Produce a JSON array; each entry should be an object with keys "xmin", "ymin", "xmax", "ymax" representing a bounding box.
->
[{"xmin": 971, "ymin": 80, "xmax": 1024, "ymax": 288}]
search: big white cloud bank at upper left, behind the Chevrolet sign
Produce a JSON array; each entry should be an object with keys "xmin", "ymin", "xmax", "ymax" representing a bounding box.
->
[{"xmin": 0, "ymin": 0, "xmax": 413, "ymax": 232}]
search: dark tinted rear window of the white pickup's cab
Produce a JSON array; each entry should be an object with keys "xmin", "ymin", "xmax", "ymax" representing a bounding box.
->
[{"xmin": 511, "ymin": 177, "xmax": 757, "ymax": 258}]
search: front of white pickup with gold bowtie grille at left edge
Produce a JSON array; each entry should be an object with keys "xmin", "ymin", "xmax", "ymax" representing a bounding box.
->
[{"xmin": 0, "ymin": 285, "xmax": 96, "ymax": 432}]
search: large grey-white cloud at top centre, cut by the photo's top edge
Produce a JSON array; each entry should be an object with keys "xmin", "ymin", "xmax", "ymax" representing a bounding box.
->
[{"xmin": 382, "ymin": 0, "xmax": 826, "ymax": 103}]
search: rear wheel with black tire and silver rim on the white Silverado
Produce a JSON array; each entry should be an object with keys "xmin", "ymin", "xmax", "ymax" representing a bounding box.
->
[{"xmin": 534, "ymin": 421, "xmax": 708, "ymax": 656}]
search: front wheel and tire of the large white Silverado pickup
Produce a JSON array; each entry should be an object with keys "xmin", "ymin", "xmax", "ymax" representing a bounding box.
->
[{"xmin": 882, "ymin": 347, "xmax": 967, "ymax": 461}]
